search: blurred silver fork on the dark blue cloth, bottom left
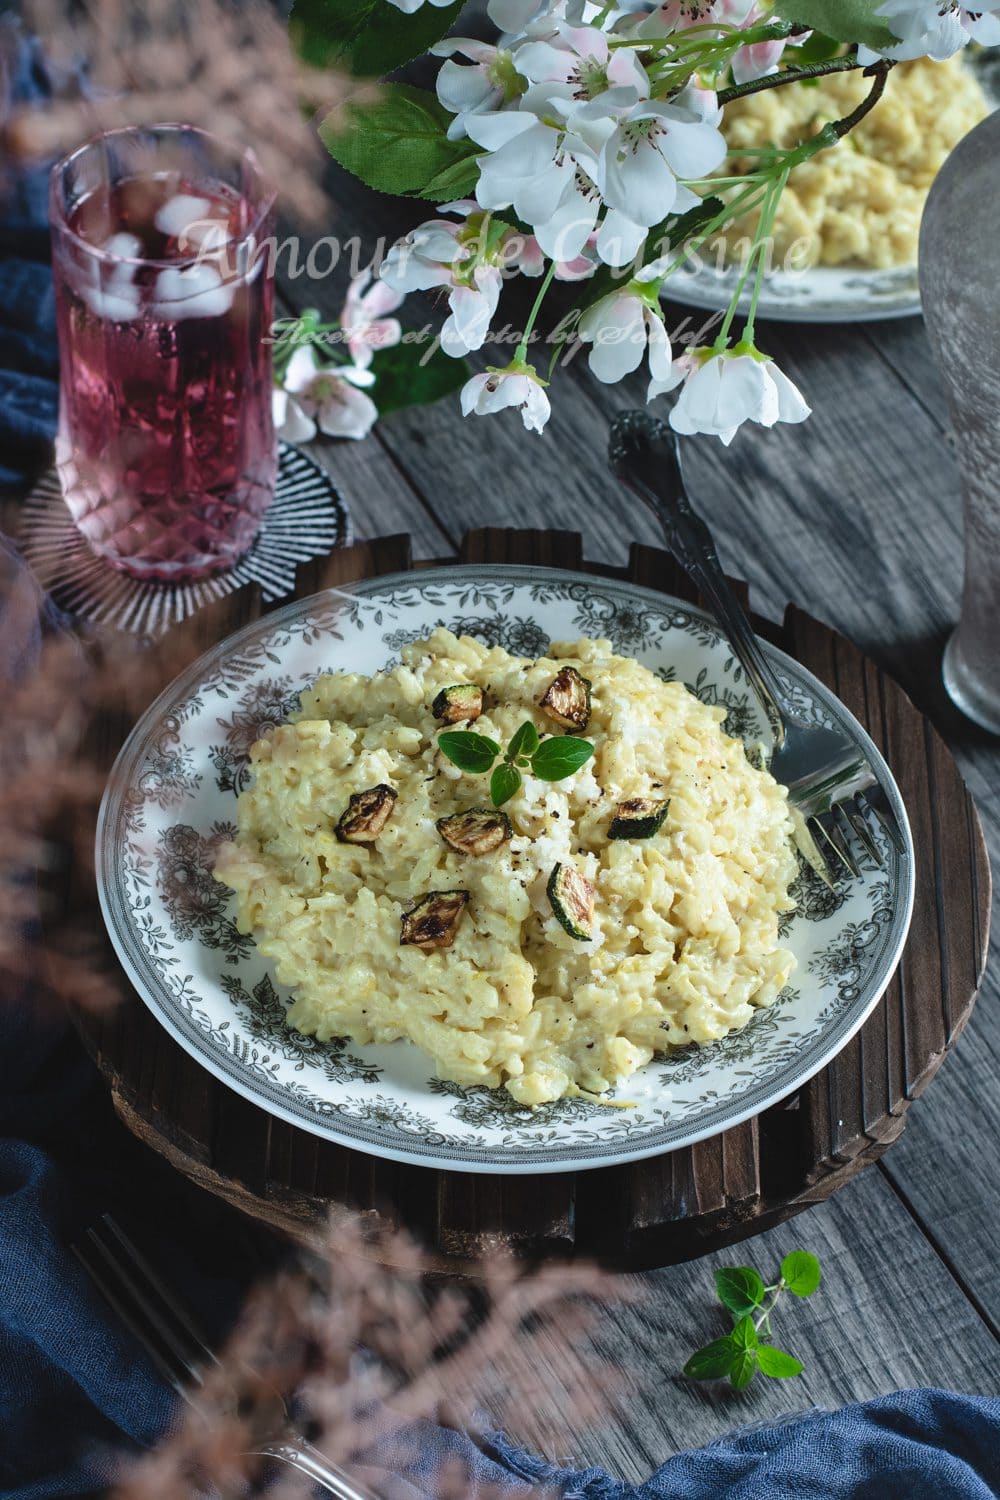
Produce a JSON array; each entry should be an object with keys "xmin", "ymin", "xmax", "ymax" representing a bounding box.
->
[{"xmin": 70, "ymin": 1214, "xmax": 378, "ymax": 1500}]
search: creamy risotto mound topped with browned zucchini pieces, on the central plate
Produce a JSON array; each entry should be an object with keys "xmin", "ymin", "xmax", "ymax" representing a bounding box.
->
[{"xmin": 216, "ymin": 629, "xmax": 796, "ymax": 1106}]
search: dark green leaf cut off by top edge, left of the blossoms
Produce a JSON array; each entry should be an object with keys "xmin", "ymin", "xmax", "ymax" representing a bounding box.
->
[{"xmin": 288, "ymin": 0, "xmax": 462, "ymax": 78}]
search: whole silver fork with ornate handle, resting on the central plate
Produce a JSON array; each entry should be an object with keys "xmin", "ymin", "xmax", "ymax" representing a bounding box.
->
[{"xmin": 607, "ymin": 411, "xmax": 906, "ymax": 882}]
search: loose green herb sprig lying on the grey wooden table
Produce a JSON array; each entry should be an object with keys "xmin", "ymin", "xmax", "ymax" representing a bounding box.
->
[{"xmin": 684, "ymin": 1250, "xmax": 822, "ymax": 1391}]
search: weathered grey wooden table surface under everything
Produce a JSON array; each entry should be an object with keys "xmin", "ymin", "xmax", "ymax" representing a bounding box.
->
[{"xmin": 239, "ymin": 155, "xmax": 1000, "ymax": 1479}]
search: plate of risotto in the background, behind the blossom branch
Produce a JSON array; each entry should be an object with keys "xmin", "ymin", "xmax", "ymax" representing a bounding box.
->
[{"xmin": 666, "ymin": 53, "xmax": 997, "ymax": 323}]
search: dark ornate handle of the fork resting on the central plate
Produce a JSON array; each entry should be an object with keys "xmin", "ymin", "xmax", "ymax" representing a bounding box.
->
[{"xmin": 609, "ymin": 411, "xmax": 784, "ymax": 750}]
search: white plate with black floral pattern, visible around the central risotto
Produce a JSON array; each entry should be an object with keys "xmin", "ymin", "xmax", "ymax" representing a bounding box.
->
[{"xmin": 96, "ymin": 566, "xmax": 913, "ymax": 1173}]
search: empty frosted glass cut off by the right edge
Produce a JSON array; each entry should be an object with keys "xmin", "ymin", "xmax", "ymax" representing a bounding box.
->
[{"xmin": 921, "ymin": 114, "xmax": 1000, "ymax": 734}]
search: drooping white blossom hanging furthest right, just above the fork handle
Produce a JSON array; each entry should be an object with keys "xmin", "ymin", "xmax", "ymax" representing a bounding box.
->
[{"xmin": 646, "ymin": 344, "xmax": 810, "ymax": 446}]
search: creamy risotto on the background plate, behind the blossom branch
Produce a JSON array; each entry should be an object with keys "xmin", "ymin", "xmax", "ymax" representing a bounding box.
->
[{"xmin": 723, "ymin": 57, "xmax": 990, "ymax": 270}]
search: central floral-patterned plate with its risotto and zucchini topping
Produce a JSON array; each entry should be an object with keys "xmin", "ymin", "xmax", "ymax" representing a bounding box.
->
[{"xmin": 97, "ymin": 566, "xmax": 913, "ymax": 1173}]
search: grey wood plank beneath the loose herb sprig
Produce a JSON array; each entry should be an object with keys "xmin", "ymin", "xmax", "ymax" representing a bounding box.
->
[{"xmin": 479, "ymin": 1172, "xmax": 1000, "ymax": 1482}]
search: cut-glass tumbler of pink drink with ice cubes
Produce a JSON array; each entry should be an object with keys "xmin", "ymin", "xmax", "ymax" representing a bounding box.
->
[{"xmin": 52, "ymin": 126, "xmax": 276, "ymax": 579}]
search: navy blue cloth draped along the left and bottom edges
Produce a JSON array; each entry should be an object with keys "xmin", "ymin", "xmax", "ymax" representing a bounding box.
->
[{"xmin": 0, "ymin": 26, "xmax": 1000, "ymax": 1500}]
